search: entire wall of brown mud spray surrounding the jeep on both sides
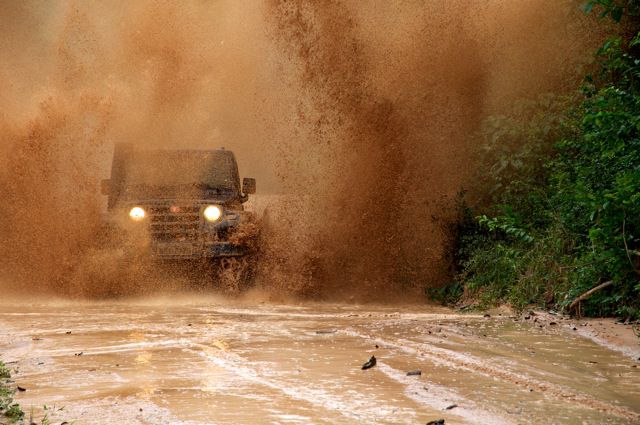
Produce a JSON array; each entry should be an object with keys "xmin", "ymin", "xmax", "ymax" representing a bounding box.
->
[{"xmin": 0, "ymin": 0, "xmax": 599, "ymax": 300}]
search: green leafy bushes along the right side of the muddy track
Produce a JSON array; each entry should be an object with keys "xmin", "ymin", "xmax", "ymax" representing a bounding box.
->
[{"xmin": 444, "ymin": 0, "xmax": 640, "ymax": 319}]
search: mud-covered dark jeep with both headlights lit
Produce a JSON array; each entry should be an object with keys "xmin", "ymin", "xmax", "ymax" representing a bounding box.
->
[{"xmin": 101, "ymin": 144, "xmax": 259, "ymax": 286}]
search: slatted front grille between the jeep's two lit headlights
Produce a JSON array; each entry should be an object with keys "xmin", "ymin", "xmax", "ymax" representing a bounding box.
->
[{"xmin": 147, "ymin": 205, "xmax": 201, "ymax": 242}]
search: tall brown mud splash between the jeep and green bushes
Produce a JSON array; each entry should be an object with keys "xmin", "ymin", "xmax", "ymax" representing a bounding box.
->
[{"xmin": 268, "ymin": 0, "xmax": 599, "ymax": 301}]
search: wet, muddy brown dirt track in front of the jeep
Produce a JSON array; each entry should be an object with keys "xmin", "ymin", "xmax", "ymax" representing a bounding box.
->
[{"xmin": 0, "ymin": 297, "xmax": 640, "ymax": 424}]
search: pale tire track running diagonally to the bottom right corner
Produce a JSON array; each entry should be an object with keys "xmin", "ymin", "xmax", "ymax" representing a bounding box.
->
[{"xmin": 343, "ymin": 330, "xmax": 640, "ymax": 423}]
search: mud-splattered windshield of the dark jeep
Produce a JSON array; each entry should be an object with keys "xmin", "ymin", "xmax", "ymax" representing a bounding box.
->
[{"xmin": 125, "ymin": 150, "xmax": 238, "ymax": 190}]
